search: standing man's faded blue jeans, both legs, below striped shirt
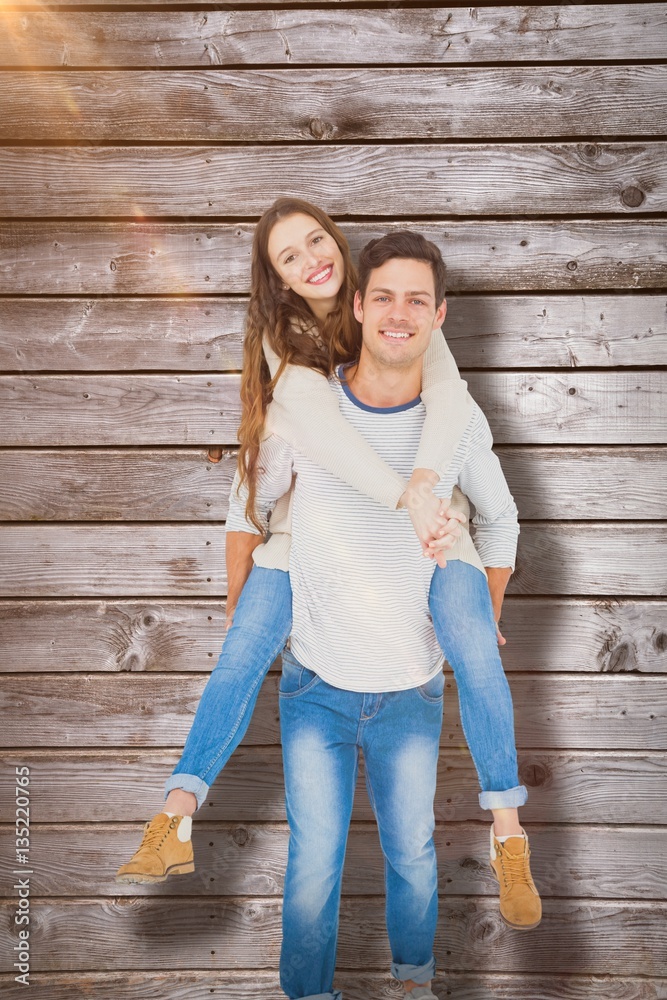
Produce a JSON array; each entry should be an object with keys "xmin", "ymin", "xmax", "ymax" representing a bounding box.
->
[{"xmin": 280, "ymin": 650, "xmax": 445, "ymax": 1000}]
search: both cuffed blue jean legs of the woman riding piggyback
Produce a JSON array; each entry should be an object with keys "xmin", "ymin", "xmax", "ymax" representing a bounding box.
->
[{"xmin": 165, "ymin": 560, "xmax": 527, "ymax": 809}]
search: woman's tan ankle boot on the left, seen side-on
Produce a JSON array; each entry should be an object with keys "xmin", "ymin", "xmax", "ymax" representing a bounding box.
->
[{"xmin": 116, "ymin": 813, "xmax": 195, "ymax": 882}]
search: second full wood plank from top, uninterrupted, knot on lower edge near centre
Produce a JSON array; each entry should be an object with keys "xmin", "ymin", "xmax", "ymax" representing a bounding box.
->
[{"xmin": 0, "ymin": 65, "xmax": 667, "ymax": 142}]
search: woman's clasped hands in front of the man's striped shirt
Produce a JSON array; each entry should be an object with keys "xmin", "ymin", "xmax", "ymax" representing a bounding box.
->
[{"xmin": 399, "ymin": 469, "xmax": 466, "ymax": 568}]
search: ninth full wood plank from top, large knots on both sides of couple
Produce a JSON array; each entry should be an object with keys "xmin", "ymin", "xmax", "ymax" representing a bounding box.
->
[{"xmin": 0, "ymin": 595, "xmax": 667, "ymax": 674}]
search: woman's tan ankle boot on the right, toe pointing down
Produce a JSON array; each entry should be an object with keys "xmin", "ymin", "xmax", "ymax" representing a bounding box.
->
[{"xmin": 491, "ymin": 824, "xmax": 542, "ymax": 931}]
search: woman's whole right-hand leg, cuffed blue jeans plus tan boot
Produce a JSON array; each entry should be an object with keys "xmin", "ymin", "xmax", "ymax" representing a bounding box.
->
[{"xmin": 429, "ymin": 560, "xmax": 542, "ymax": 930}]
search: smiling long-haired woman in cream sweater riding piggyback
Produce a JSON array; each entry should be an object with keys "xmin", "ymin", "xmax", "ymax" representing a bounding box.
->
[{"xmin": 117, "ymin": 198, "xmax": 539, "ymax": 927}]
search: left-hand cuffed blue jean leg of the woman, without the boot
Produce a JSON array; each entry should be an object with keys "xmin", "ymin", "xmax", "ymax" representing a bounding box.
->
[{"xmin": 165, "ymin": 566, "xmax": 292, "ymax": 808}]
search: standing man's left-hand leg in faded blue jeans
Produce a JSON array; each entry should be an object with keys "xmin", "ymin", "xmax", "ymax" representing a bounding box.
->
[{"xmin": 280, "ymin": 653, "xmax": 363, "ymax": 1000}]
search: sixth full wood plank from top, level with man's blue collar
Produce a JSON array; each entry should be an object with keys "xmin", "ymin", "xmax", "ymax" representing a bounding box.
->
[{"xmin": 0, "ymin": 370, "xmax": 667, "ymax": 447}]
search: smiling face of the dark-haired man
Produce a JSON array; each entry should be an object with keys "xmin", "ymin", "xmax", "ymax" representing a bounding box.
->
[{"xmin": 354, "ymin": 257, "xmax": 447, "ymax": 368}]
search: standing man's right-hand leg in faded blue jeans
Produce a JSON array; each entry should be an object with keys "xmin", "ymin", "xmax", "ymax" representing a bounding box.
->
[{"xmin": 361, "ymin": 672, "xmax": 444, "ymax": 990}]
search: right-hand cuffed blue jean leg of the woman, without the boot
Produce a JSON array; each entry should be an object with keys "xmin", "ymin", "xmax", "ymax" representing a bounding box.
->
[{"xmin": 429, "ymin": 559, "xmax": 528, "ymax": 810}]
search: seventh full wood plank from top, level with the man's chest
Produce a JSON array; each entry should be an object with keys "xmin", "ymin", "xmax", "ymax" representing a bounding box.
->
[{"xmin": 0, "ymin": 446, "xmax": 667, "ymax": 521}]
